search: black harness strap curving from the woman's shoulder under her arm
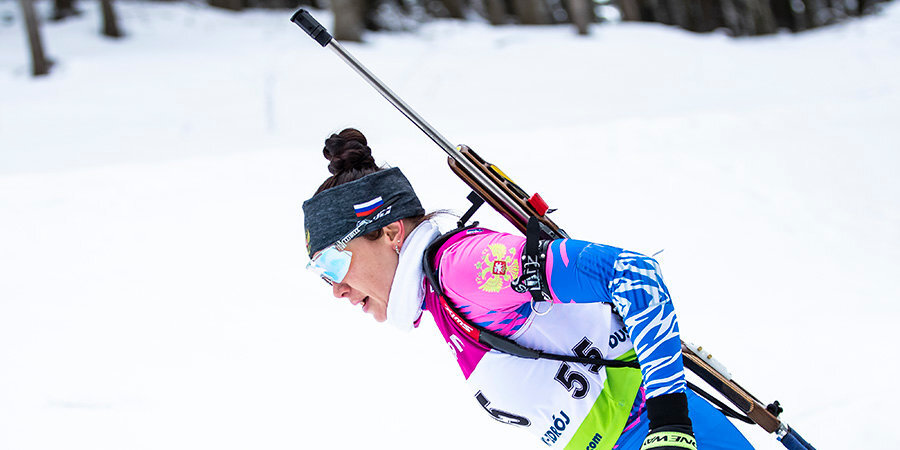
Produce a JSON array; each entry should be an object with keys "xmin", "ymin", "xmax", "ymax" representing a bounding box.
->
[{"xmin": 422, "ymin": 222, "xmax": 640, "ymax": 369}]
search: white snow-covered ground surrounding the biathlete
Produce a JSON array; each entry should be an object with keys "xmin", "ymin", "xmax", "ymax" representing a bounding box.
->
[{"xmin": 0, "ymin": 0, "xmax": 900, "ymax": 450}]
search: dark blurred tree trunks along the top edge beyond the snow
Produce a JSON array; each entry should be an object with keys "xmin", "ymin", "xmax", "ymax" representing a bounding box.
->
[{"xmin": 12, "ymin": 0, "xmax": 888, "ymax": 76}]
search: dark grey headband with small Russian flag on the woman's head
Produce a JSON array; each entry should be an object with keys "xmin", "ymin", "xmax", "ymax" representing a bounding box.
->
[{"xmin": 303, "ymin": 167, "xmax": 425, "ymax": 258}]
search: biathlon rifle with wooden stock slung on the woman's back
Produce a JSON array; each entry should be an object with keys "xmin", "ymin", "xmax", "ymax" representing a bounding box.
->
[{"xmin": 291, "ymin": 9, "xmax": 815, "ymax": 450}]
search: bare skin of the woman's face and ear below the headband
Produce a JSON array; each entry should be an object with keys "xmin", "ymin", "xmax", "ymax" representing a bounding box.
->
[{"xmin": 332, "ymin": 221, "xmax": 404, "ymax": 322}]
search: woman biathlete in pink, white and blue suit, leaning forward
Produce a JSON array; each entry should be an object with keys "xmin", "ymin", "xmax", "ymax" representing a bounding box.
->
[{"xmin": 303, "ymin": 129, "xmax": 753, "ymax": 450}]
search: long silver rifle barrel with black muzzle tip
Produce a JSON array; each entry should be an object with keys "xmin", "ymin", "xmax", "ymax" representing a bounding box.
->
[{"xmin": 291, "ymin": 9, "xmax": 529, "ymax": 229}]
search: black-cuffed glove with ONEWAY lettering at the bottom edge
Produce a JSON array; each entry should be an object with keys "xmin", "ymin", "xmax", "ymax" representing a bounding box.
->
[{"xmin": 641, "ymin": 393, "xmax": 697, "ymax": 450}]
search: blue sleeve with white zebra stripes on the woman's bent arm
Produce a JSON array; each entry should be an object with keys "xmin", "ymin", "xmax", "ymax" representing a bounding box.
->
[{"xmin": 548, "ymin": 239, "xmax": 685, "ymax": 398}]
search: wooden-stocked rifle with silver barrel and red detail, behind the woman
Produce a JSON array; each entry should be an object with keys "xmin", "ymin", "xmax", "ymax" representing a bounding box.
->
[{"xmin": 291, "ymin": 9, "xmax": 815, "ymax": 450}]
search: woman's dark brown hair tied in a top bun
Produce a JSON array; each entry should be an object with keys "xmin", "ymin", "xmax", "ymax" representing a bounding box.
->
[{"xmin": 316, "ymin": 128, "xmax": 437, "ymax": 241}]
